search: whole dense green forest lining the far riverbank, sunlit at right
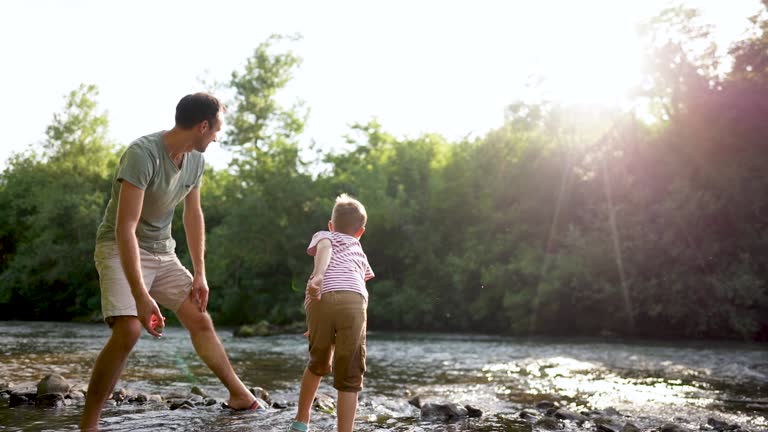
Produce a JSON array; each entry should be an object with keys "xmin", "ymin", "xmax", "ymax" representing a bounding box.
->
[{"xmin": 0, "ymin": 2, "xmax": 768, "ymax": 340}]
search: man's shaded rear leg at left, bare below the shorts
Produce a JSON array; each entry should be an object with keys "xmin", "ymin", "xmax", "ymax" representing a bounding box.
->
[{"xmin": 80, "ymin": 316, "xmax": 142, "ymax": 431}]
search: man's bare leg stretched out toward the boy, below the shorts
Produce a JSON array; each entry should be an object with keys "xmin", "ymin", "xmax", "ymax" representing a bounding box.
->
[{"xmin": 176, "ymin": 296, "xmax": 255, "ymax": 409}]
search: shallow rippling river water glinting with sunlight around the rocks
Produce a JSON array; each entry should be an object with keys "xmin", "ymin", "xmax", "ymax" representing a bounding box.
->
[{"xmin": 0, "ymin": 322, "xmax": 768, "ymax": 431}]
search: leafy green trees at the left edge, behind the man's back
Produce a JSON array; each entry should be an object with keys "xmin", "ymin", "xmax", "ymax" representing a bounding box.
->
[{"xmin": 0, "ymin": 85, "xmax": 116, "ymax": 319}]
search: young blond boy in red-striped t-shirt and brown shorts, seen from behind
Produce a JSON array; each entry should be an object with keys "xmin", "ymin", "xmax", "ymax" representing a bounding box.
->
[{"xmin": 288, "ymin": 194, "xmax": 374, "ymax": 432}]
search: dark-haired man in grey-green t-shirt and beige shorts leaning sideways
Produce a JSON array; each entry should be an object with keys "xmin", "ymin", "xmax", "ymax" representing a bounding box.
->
[{"xmin": 80, "ymin": 93, "xmax": 262, "ymax": 430}]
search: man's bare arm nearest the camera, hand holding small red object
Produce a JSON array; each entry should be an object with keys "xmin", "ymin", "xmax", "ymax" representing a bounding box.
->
[{"xmin": 115, "ymin": 180, "xmax": 165, "ymax": 337}]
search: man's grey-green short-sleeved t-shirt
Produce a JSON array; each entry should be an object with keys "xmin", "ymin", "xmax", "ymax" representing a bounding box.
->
[{"xmin": 96, "ymin": 132, "xmax": 204, "ymax": 253}]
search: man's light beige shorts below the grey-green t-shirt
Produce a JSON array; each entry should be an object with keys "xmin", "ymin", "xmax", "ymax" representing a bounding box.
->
[{"xmin": 93, "ymin": 242, "xmax": 192, "ymax": 322}]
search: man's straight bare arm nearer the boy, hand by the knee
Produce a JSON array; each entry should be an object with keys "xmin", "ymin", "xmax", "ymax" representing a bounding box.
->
[{"xmin": 184, "ymin": 187, "xmax": 209, "ymax": 312}]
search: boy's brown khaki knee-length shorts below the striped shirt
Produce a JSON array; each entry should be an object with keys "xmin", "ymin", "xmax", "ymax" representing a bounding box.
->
[{"xmin": 307, "ymin": 291, "xmax": 368, "ymax": 392}]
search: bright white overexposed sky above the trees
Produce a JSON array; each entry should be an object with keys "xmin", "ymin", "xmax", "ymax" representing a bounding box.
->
[{"xmin": 0, "ymin": 0, "xmax": 760, "ymax": 167}]
